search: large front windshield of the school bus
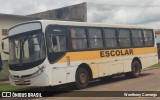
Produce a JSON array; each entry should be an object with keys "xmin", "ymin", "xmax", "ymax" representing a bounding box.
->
[{"xmin": 9, "ymin": 30, "xmax": 45, "ymax": 65}]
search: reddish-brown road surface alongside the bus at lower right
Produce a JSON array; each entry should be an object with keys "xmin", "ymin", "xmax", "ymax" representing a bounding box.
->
[{"xmin": 42, "ymin": 69, "xmax": 160, "ymax": 100}]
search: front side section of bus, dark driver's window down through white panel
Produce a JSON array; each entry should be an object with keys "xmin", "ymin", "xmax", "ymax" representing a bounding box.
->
[{"xmin": 46, "ymin": 25, "xmax": 67, "ymax": 85}]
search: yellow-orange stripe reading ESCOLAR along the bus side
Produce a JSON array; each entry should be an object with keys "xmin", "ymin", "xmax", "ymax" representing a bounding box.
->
[{"xmin": 57, "ymin": 47, "xmax": 157, "ymax": 63}]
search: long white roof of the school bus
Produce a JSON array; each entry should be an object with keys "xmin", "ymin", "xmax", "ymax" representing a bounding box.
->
[{"xmin": 10, "ymin": 20, "xmax": 153, "ymax": 29}]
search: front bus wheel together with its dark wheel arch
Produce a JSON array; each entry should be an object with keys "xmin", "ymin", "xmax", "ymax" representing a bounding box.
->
[{"xmin": 75, "ymin": 63, "xmax": 93, "ymax": 89}]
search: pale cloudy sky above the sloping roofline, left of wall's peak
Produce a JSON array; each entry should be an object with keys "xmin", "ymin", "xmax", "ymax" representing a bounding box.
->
[{"xmin": 0, "ymin": 0, "xmax": 81, "ymax": 15}]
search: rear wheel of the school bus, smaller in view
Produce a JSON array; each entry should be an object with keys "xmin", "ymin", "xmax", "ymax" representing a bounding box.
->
[{"xmin": 125, "ymin": 61, "xmax": 141, "ymax": 78}]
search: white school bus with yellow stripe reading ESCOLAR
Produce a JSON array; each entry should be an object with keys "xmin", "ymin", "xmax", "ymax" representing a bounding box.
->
[{"xmin": 8, "ymin": 20, "xmax": 158, "ymax": 89}]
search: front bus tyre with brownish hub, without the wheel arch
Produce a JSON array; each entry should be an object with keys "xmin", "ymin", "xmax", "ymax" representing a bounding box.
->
[{"xmin": 76, "ymin": 68, "xmax": 89, "ymax": 89}]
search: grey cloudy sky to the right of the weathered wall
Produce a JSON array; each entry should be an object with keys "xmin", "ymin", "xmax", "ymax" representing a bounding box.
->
[{"xmin": 88, "ymin": 0, "xmax": 160, "ymax": 27}]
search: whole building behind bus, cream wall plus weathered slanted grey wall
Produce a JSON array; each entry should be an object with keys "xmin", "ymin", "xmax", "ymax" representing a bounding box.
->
[{"xmin": 0, "ymin": 3, "xmax": 87, "ymax": 60}]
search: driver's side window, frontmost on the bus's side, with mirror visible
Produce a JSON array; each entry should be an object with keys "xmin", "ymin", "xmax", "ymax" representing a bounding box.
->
[{"xmin": 46, "ymin": 26, "xmax": 67, "ymax": 53}]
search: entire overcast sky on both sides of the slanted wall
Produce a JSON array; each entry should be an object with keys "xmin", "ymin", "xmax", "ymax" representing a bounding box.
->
[{"xmin": 0, "ymin": 0, "xmax": 160, "ymax": 28}]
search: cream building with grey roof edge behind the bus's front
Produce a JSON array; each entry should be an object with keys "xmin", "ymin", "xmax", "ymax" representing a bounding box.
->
[{"xmin": 0, "ymin": 14, "xmax": 35, "ymax": 60}]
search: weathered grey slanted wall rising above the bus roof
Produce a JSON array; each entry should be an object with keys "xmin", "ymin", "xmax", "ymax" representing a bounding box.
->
[{"xmin": 27, "ymin": 3, "xmax": 87, "ymax": 22}]
